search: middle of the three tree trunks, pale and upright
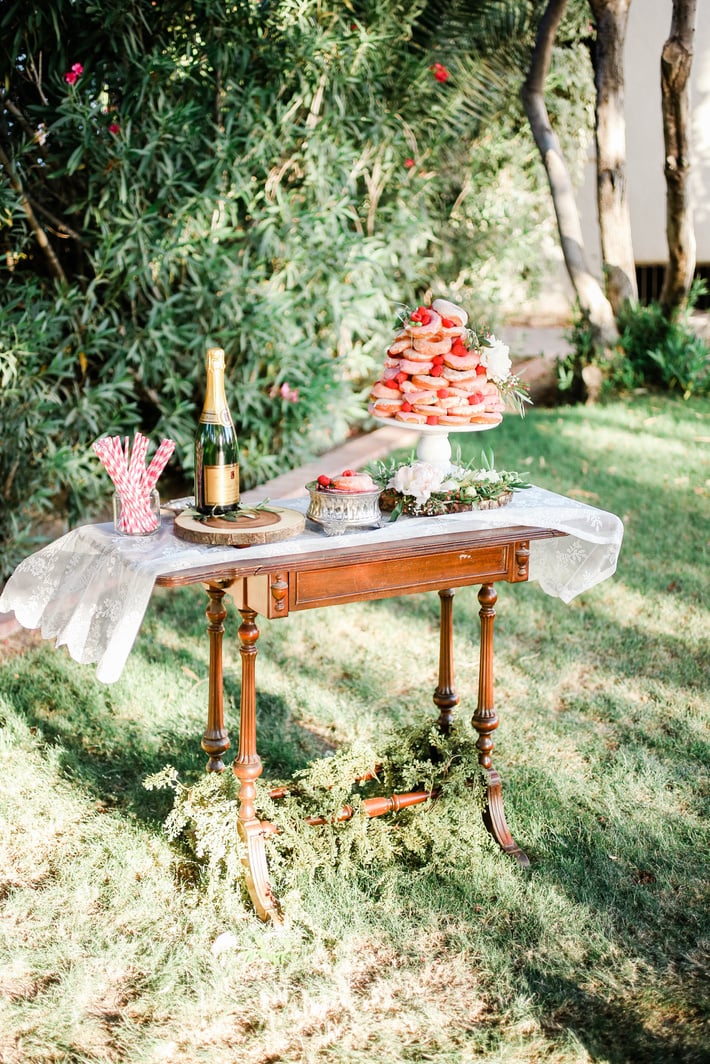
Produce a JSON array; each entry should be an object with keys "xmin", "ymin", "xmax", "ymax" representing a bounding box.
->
[{"xmin": 590, "ymin": 0, "xmax": 639, "ymax": 315}]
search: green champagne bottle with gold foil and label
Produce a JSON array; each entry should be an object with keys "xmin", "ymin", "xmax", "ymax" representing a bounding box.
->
[{"xmin": 195, "ymin": 347, "xmax": 240, "ymax": 517}]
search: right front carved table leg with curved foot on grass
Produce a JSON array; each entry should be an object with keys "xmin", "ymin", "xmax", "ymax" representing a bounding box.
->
[{"xmin": 472, "ymin": 584, "xmax": 530, "ymax": 867}]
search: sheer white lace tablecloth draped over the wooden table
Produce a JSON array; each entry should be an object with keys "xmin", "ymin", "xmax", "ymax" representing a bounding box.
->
[{"xmin": 0, "ymin": 487, "xmax": 624, "ymax": 683}]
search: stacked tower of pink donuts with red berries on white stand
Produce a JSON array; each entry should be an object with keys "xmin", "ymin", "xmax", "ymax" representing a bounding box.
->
[{"xmin": 368, "ymin": 299, "xmax": 503, "ymax": 428}]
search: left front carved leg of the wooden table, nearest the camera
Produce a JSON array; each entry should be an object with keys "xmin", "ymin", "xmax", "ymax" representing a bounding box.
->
[{"xmin": 232, "ymin": 609, "xmax": 280, "ymax": 922}]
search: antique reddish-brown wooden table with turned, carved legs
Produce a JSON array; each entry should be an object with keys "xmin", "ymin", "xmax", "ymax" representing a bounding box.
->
[{"xmin": 156, "ymin": 527, "xmax": 564, "ymax": 919}]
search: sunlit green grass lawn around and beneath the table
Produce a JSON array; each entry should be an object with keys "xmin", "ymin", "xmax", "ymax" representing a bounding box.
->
[{"xmin": 0, "ymin": 397, "xmax": 710, "ymax": 1064}]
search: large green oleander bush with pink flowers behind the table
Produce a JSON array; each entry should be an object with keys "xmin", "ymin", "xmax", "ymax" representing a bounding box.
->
[{"xmin": 0, "ymin": 0, "xmax": 585, "ymax": 573}]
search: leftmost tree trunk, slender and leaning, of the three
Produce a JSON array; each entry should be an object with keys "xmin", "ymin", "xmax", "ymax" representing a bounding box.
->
[{"xmin": 523, "ymin": 0, "xmax": 618, "ymax": 347}]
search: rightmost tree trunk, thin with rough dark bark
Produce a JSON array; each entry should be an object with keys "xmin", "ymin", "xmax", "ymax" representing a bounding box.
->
[{"xmin": 661, "ymin": 0, "xmax": 696, "ymax": 314}]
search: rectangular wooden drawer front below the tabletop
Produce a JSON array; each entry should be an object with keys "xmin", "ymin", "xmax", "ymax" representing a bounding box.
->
[{"xmin": 288, "ymin": 544, "xmax": 519, "ymax": 610}]
